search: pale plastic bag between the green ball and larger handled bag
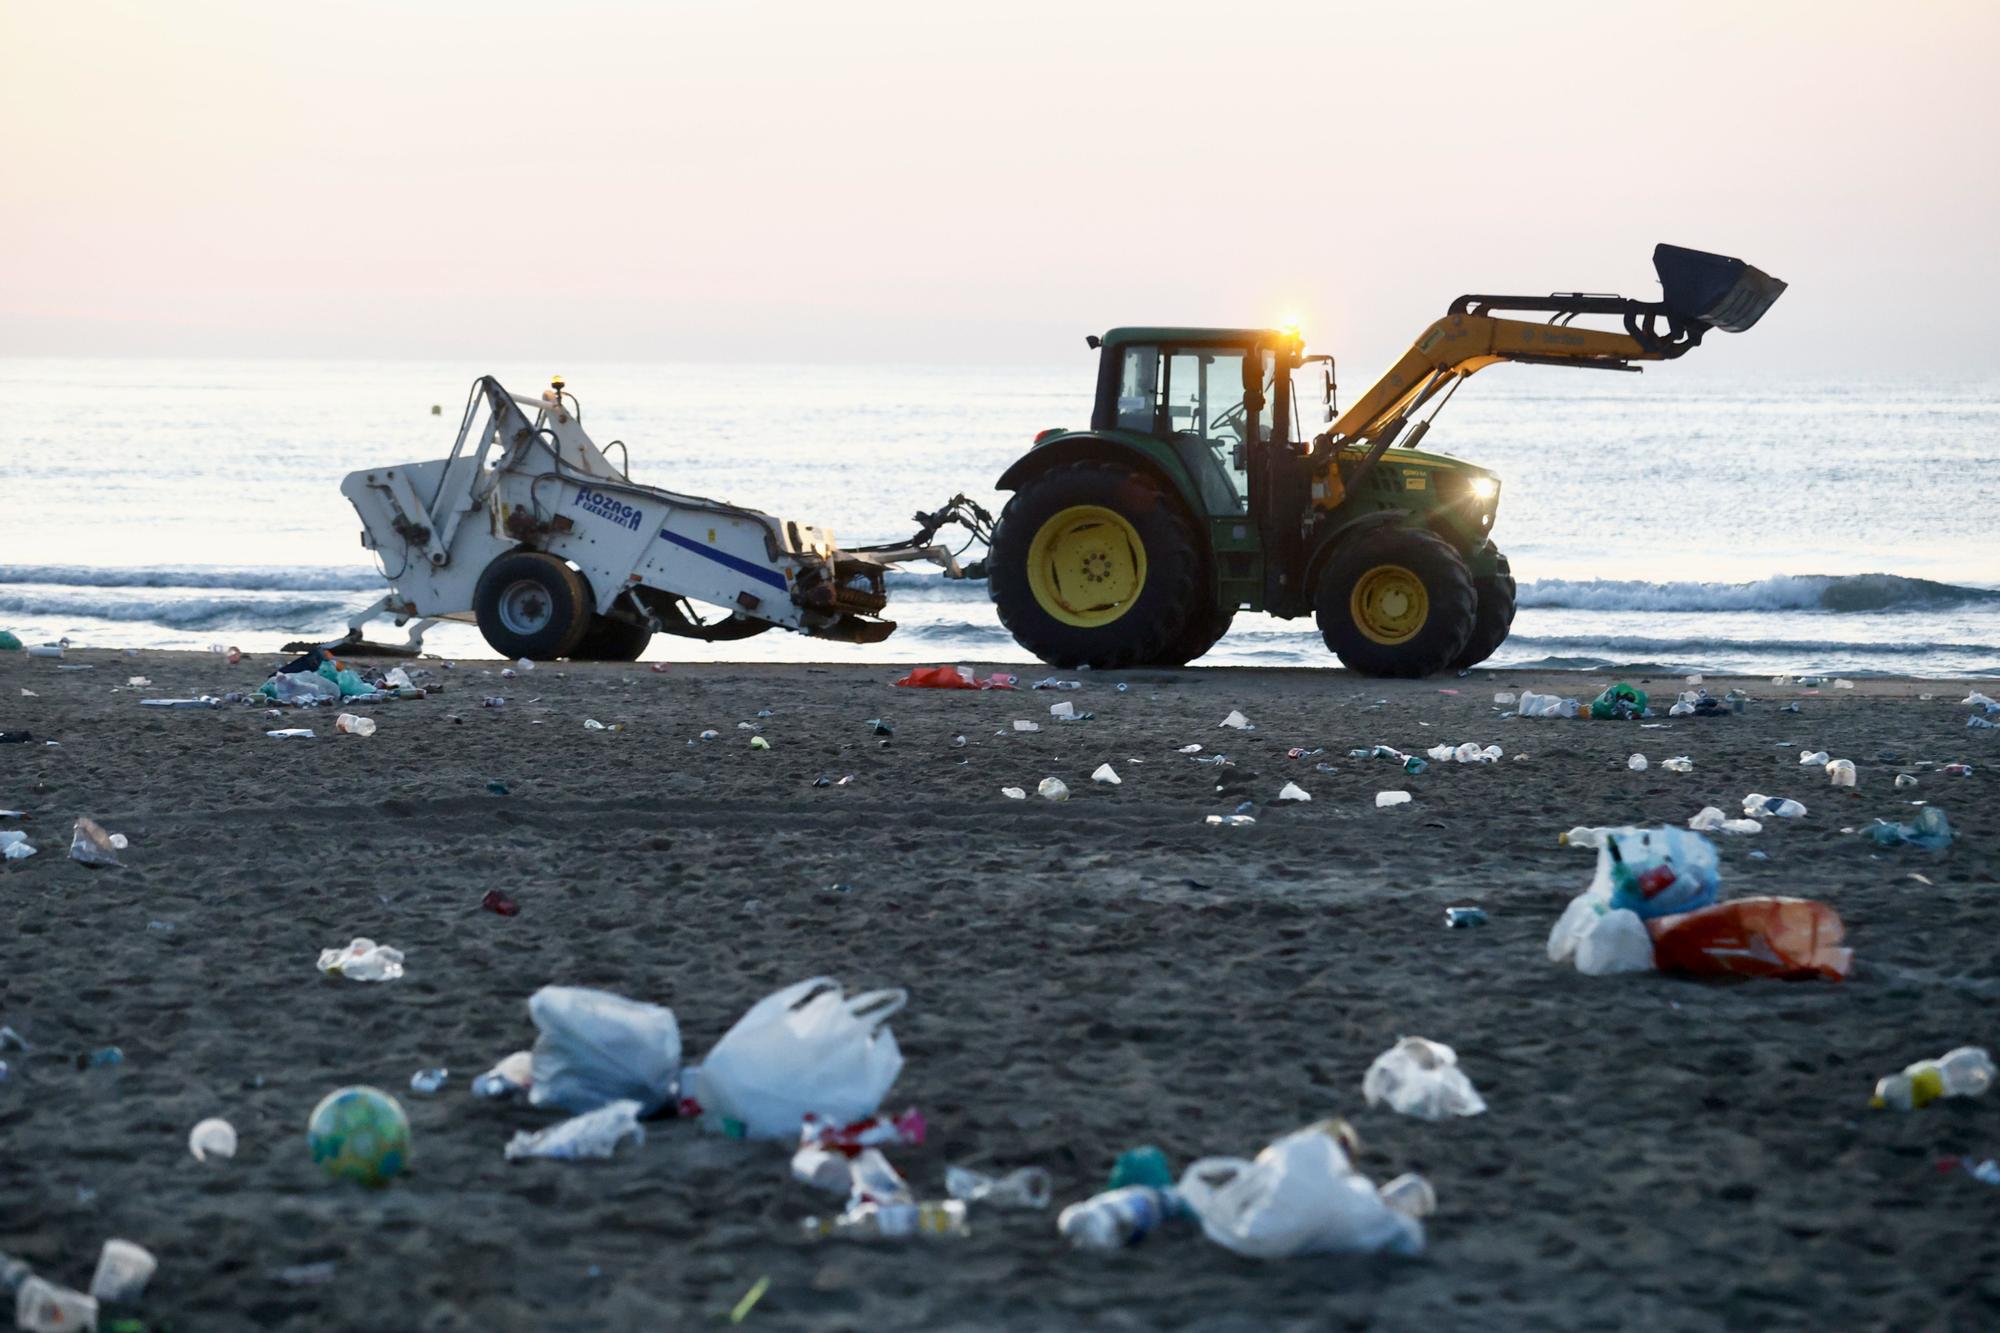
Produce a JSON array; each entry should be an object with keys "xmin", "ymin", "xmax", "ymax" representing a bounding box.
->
[{"xmin": 528, "ymin": 987, "xmax": 680, "ymax": 1115}]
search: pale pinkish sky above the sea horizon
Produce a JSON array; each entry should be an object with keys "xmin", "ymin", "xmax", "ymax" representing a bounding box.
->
[{"xmin": 0, "ymin": 0, "xmax": 2000, "ymax": 374}]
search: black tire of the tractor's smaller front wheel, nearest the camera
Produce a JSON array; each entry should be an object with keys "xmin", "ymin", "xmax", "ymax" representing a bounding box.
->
[{"xmin": 1312, "ymin": 528, "xmax": 1480, "ymax": 677}]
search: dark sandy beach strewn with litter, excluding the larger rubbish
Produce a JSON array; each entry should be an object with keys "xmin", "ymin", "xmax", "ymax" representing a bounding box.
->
[{"xmin": 0, "ymin": 652, "xmax": 2000, "ymax": 1333}]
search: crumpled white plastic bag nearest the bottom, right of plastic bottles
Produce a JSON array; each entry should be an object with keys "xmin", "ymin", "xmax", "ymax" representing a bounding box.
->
[{"xmin": 1180, "ymin": 1125, "xmax": 1424, "ymax": 1259}]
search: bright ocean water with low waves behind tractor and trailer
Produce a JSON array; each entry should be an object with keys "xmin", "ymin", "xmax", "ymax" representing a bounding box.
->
[{"xmin": 0, "ymin": 358, "xmax": 2000, "ymax": 677}]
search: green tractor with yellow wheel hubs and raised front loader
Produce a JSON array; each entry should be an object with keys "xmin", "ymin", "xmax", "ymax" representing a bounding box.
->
[{"xmin": 988, "ymin": 244, "xmax": 1784, "ymax": 677}]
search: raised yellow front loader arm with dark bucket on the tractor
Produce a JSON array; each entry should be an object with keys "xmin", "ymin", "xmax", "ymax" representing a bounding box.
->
[{"xmin": 1310, "ymin": 244, "xmax": 1784, "ymax": 508}]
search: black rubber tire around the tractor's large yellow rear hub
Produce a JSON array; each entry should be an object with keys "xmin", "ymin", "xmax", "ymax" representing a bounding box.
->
[{"xmin": 988, "ymin": 462, "xmax": 1208, "ymax": 671}]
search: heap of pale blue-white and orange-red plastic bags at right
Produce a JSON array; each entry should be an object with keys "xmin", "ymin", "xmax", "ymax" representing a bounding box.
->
[{"xmin": 1548, "ymin": 827, "xmax": 1852, "ymax": 981}]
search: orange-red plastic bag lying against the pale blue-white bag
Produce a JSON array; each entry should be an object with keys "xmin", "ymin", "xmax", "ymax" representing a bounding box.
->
[{"xmin": 1646, "ymin": 899, "xmax": 1854, "ymax": 981}]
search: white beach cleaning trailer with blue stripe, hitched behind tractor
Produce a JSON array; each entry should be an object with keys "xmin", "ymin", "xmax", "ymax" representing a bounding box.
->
[{"xmin": 340, "ymin": 376, "xmax": 992, "ymax": 660}]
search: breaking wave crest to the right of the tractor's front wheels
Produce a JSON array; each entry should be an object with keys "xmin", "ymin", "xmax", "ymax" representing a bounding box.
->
[{"xmin": 1520, "ymin": 574, "xmax": 2000, "ymax": 610}]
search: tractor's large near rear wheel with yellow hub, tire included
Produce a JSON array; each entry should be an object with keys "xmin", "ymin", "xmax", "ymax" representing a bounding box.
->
[{"xmin": 988, "ymin": 462, "xmax": 1206, "ymax": 671}]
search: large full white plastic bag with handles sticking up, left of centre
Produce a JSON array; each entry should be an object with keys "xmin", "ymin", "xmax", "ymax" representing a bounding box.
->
[{"xmin": 692, "ymin": 977, "xmax": 910, "ymax": 1139}]
